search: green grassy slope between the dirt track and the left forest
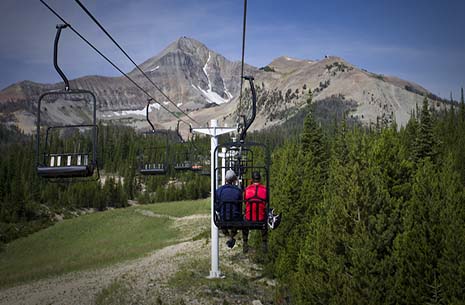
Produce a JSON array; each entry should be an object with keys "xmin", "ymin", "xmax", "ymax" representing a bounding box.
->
[{"xmin": 0, "ymin": 200, "xmax": 209, "ymax": 287}]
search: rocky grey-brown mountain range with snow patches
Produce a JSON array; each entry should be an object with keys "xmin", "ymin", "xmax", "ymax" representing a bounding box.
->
[{"xmin": 0, "ymin": 37, "xmax": 442, "ymax": 132}]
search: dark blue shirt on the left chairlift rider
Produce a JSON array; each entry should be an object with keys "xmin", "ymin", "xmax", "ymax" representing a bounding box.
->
[{"xmin": 215, "ymin": 184, "xmax": 242, "ymax": 221}]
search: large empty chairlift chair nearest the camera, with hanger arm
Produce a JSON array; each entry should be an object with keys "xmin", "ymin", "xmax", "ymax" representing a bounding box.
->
[{"xmin": 36, "ymin": 24, "xmax": 99, "ymax": 181}]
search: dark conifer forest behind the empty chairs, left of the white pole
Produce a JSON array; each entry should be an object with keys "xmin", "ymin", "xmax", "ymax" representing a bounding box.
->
[{"xmin": 0, "ymin": 125, "xmax": 210, "ymax": 243}]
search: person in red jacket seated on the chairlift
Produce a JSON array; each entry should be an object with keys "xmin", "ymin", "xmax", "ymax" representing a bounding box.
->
[{"xmin": 242, "ymin": 172, "xmax": 268, "ymax": 253}]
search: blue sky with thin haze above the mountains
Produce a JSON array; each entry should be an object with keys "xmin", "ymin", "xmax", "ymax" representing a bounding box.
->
[{"xmin": 0, "ymin": 0, "xmax": 465, "ymax": 99}]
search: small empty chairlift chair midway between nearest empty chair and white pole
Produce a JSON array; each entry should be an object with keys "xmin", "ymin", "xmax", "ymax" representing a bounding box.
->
[{"xmin": 138, "ymin": 99, "xmax": 168, "ymax": 176}]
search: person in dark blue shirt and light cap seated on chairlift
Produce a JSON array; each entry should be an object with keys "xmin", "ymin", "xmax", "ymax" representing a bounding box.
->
[{"xmin": 215, "ymin": 169, "xmax": 242, "ymax": 248}]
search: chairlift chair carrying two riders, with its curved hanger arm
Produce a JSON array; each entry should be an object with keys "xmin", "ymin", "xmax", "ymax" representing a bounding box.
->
[{"xmin": 213, "ymin": 76, "xmax": 270, "ymax": 230}]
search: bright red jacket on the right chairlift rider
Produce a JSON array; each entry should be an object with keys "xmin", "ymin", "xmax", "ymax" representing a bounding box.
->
[{"xmin": 244, "ymin": 183, "xmax": 266, "ymax": 221}]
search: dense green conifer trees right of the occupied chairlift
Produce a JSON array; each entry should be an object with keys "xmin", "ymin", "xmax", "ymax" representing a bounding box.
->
[{"xmin": 267, "ymin": 94, "xmax": 465, "ymax": 305}]
